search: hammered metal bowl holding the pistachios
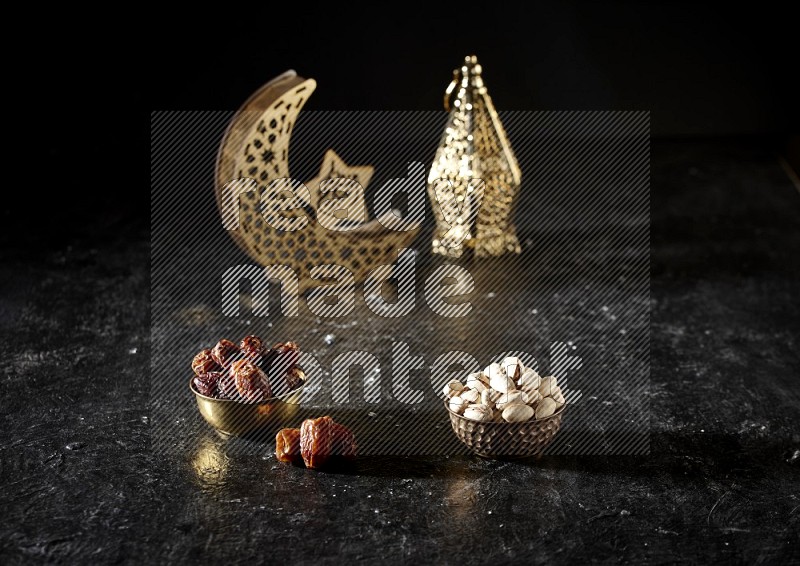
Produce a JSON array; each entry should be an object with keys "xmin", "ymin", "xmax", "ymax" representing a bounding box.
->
[{"xmin": 444, "ymin": 399, "xmax": 566, "ymax": 458}]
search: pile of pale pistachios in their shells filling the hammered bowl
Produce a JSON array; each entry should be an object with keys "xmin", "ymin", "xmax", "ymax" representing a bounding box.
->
[{"xmin": 444, "ymin": 357, "xmax": 566, "ymax": 423}]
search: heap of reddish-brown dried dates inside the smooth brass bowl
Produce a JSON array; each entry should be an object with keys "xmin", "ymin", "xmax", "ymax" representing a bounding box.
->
[{"xmin": 192, "ymin": 335, "xmax": 305, "ymax": 404}]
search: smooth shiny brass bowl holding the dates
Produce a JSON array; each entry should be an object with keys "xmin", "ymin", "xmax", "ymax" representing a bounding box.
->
[{"xmin": 189, "ymin": 371, "xmax": 306, "ymax": 436}]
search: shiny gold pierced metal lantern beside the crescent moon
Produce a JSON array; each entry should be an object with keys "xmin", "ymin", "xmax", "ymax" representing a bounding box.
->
[{"xmin": 428, "ymin": 55, "xmax": 522, "ymax": 258}]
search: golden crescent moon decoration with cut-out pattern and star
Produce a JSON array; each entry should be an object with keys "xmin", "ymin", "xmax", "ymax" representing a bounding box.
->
[{"xmin": 214, "ymin": 71, "xmax": 419, "ymax": 292}]
